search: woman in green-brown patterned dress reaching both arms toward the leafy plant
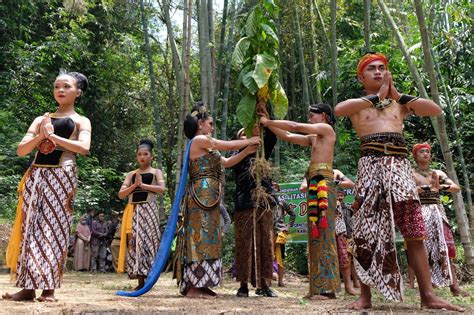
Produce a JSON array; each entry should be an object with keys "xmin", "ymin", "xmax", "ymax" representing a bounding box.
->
[{"xmin": 175, "ymin": 102, "xmax": 260, "ymax": 298}]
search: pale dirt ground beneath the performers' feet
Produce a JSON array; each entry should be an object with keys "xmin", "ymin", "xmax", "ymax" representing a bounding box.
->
[{"xmin": 0, "ymin": 272, "xmax": 474, "ymax": 314}]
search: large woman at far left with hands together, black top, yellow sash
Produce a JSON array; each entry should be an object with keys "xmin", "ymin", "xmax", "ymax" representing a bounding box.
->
[{"xmin": 2, "ymin": 72, "xmax": 91, "ymax": 302}]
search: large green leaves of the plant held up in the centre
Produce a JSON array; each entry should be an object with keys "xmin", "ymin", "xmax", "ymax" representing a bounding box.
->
[{"xmin": 232, "ymin": 0, "xmax": 288, "ymax": 137}]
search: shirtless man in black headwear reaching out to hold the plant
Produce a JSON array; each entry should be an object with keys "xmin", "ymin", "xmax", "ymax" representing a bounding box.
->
[{"xmin": 259, "ymin": 104, "xmax": 340, "ymax": 299}]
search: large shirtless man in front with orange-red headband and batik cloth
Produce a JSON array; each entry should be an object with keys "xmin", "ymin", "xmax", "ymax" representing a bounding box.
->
[{"xmin": 335, "ymin": 53, "xmax": 461, "ymax": 310}]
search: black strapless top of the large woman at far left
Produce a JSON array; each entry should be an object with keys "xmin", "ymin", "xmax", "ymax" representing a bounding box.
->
[{"xmin": 33, "ymin": 117, "xmax": 76, "ymax": 167}]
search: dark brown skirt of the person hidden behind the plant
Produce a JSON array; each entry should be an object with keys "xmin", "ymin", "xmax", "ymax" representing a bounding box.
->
[{"xmin": 234, "ymin": 208, "xmax": 274, "ymax": 287}]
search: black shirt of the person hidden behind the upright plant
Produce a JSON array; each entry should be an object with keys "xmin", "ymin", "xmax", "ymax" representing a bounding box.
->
[{"xmin": 233, "ymin": 128, "xmax": 277, "ymax": 212}]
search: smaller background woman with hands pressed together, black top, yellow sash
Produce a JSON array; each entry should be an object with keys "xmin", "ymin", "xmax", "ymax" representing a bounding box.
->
[{"xmin": 117, "ymin": 139, "xmax": 165, "ymax": 290}]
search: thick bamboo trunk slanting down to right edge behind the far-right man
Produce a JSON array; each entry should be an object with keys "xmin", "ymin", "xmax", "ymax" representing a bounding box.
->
[{"xmin": 414, "ymin": 0, "xmax": 474, "ymax": 268}]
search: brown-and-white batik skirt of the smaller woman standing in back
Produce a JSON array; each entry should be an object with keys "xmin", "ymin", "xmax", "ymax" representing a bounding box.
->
[{"xmin": 127, "ymin": 201, "xmax": 160, "ymax": 279}]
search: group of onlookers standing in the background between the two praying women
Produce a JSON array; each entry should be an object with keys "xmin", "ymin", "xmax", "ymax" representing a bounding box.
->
[{"xmin": 70, "ymin": 209, "xmax": 122, "ymax": 272}]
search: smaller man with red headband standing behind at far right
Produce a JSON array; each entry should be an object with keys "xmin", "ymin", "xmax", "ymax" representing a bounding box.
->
[{"xmin": 412, "ymin": 142, "xmax": 469, "ymax": 296}]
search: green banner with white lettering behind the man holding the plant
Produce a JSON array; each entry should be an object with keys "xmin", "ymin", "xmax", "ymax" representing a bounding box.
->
[{"xmin": 277, "ymin": 183, "xmax": 354, "ymax": 243}]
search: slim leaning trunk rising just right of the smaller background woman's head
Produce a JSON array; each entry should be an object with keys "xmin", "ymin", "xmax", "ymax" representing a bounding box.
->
[{"xmin": 140, "ymin": 0, "xmax": 165, "ymax": 212}]
